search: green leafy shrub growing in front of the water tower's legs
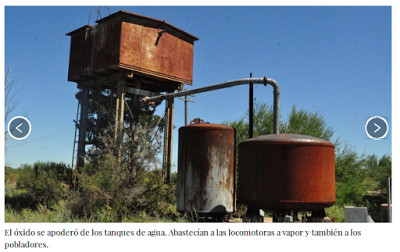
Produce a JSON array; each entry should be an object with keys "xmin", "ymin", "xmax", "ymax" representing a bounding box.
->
[{"xmin": 67, "ymin": 120, "xmax": 163, "ymax": 221}]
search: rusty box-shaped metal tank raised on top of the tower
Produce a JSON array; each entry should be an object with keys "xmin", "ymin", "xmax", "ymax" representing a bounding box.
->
[{"xmin": 67, "ymin": 11, "xmax": 198, "ymax": 84}]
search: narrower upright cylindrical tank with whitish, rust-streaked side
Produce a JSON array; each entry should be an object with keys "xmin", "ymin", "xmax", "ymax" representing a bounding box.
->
[{"xmin": 177, "ymin": 120, "xmax": 235, "ymax": 216}]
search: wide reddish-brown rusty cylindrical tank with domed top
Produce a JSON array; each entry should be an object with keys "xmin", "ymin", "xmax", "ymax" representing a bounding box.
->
[{"xmin": 238, "ymin": 134, "xmax": 336, "ymax": 211}]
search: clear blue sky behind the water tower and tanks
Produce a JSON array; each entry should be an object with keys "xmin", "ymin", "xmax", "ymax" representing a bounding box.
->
[{"xmin": 5, "ymin": 6, "xmax": 392, "ymax": 167}]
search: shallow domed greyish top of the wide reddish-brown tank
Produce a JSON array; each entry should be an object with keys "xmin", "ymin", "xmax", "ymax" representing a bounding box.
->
[{"xmin": 241, "ymin": 133, "xmax": 335, "ymax": 147}]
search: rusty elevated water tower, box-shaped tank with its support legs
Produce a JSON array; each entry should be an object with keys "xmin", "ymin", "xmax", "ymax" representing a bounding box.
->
[{"xmin": 67, "ymin": 11, "xmax": 198, "ymax": 183}]
